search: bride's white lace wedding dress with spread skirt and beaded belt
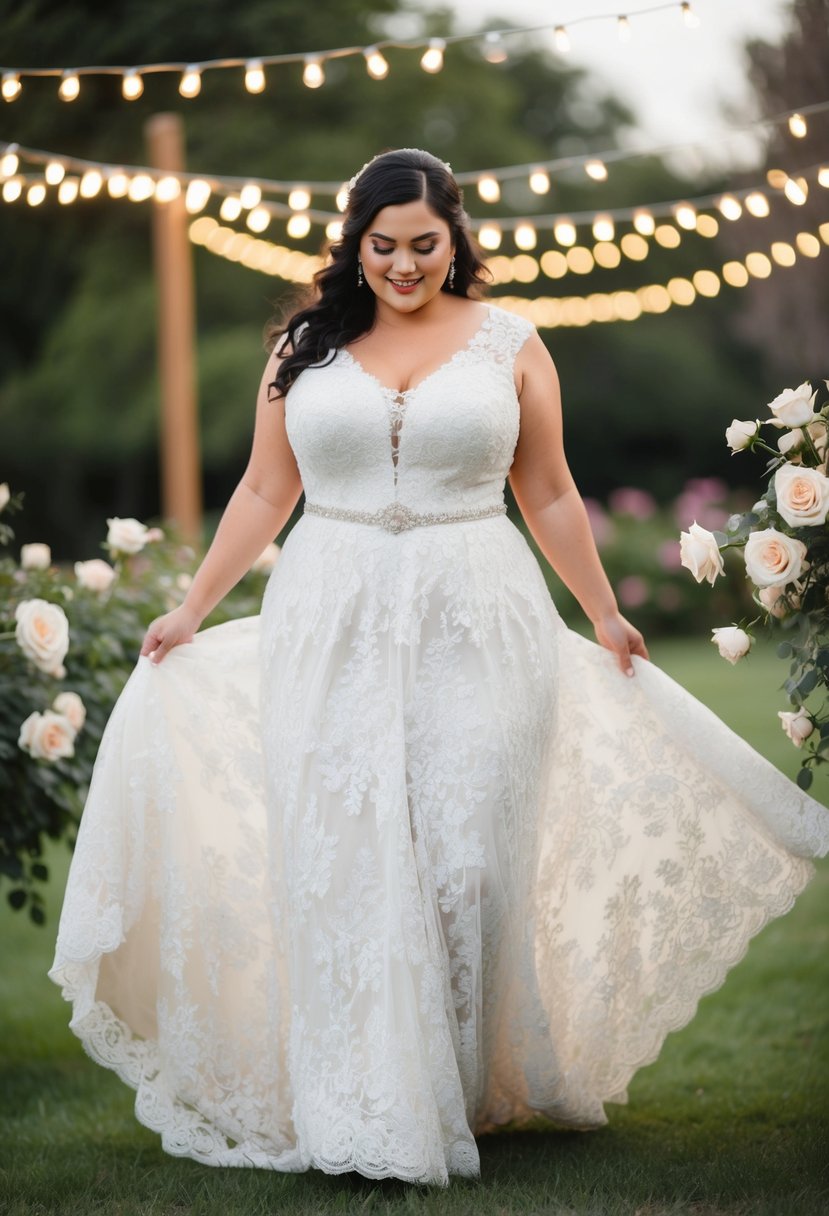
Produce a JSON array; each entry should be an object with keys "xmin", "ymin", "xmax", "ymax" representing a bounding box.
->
[{"xmin": 50, "ymin": 306, "xmax": 829, "ymax": 1183}]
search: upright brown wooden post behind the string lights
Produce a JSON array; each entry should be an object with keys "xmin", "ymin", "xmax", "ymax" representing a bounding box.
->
[{"xmin": 145, "ymin": 114, "xmax": 202, "ymax": 542}]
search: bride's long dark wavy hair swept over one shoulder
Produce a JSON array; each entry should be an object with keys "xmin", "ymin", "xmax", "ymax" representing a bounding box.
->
[{"xmin": 265, "ymin": 148, "xmax": 491, "ymax": 396}]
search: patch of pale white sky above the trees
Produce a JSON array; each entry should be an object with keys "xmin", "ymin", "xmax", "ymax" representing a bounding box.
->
[{"xmin": 403, "ymin": 0, "xmax": 789, "ymax": 168}]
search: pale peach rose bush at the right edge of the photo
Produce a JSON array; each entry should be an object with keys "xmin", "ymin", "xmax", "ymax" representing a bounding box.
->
[{"xmin": 682, "ymin": 369, "xmax": 829, "ymax": 789}]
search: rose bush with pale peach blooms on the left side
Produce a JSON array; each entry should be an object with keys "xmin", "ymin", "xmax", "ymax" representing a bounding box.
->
[{"xmin": 0, "ymin": 483, "xmax": 278, "ymax": 924}]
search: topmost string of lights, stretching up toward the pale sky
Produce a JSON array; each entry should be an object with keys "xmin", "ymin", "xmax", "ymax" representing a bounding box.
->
[{"xmin": 0, "ymin": 0, "xmax": 699, "ymax": 94}]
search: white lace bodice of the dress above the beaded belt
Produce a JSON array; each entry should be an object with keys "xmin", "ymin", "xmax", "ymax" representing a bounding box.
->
[{"xmin": 286, "ymin": 305, "xmax": 532, "ymax": 512}]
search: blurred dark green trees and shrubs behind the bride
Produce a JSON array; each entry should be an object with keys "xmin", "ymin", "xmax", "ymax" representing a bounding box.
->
[{"xmin": 0, "ymin": 0, "xmax": 829, "ymax": 631}]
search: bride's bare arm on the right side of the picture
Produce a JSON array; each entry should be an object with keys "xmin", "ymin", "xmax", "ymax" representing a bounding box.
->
[{"xmin": 509, "ymin": 333, "xmax": 648, "ymax": 676}]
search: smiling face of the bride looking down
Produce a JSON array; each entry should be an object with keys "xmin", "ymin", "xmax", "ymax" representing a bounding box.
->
[{"xmin": 360, "ymin": 199, "xmax": 455, "ymax": 313}]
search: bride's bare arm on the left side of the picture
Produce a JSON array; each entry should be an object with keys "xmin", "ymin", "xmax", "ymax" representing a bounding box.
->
[{"xmin": 141, "ymin": 355, "xmax": 303, "ymax": 663}]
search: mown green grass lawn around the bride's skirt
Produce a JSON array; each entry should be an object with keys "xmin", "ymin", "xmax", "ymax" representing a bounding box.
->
[{"xmin": 0, "ymin": 640, "xmax": 829, "ymax": 1216}]
